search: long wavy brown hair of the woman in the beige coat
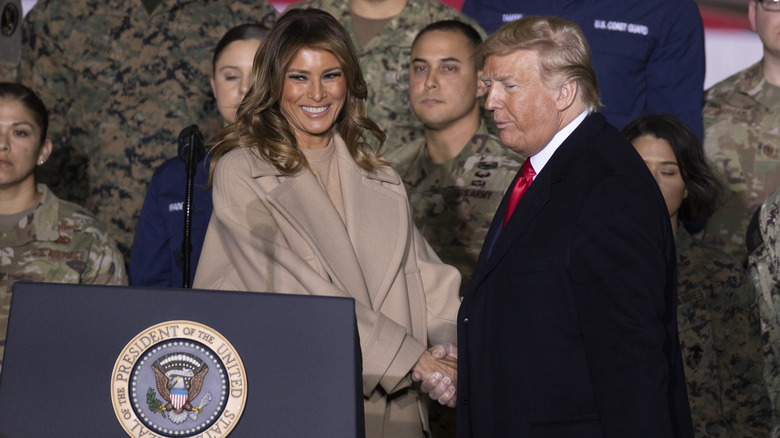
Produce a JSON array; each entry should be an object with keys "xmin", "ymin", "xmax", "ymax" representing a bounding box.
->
[{"xmin": 209, "ymin": 8, "xmax": 387, "ymax": 185}]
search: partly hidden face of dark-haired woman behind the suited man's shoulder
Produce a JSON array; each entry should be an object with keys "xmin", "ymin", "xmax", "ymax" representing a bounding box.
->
[{"xmin": 631, "ymin": 135, "xmax": 688, "ymax": 223}]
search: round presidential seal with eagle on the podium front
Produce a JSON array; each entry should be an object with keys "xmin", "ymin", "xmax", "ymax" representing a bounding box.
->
[{"xmin": 111, "ymin": 321, "xmax": 246, "ymax": 438}]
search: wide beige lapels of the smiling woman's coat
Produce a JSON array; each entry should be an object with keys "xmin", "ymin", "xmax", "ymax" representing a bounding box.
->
[{"xmin": 268, "ymin": 136, "xmax": 411, "ymax": 309}]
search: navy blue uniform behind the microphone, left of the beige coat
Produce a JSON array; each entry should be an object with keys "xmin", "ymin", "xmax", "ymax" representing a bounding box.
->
[{"xmin": 130, "ymin": 155, "xmax": 214, "ymax": 287}]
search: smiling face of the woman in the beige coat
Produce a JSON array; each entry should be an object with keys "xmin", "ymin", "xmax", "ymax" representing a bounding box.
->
[{"xmin": 279, "ymin": 48, "xmax": 347, "ymax": 149}]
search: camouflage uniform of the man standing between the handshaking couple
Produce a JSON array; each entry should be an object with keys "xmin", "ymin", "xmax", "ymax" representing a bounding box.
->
[{"xmin": 383, "ymin": 123, "xmax": 524, "ymax": 296}]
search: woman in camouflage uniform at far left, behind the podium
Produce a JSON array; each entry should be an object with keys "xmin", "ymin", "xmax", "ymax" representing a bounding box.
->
[{"xmin": 0, "ymin": 82, "xmax": 127, "ymax": 372}]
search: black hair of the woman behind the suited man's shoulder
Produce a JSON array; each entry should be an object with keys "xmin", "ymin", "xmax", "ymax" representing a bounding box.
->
[{"xmin": 623, "ymin": 114, "xmax": 721, "ymax": 220}]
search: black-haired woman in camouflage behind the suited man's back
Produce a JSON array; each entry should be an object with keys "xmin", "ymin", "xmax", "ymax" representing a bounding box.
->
[{"xmin": 623, "ymin": 114, "xmax": 772, "ymax": 438}]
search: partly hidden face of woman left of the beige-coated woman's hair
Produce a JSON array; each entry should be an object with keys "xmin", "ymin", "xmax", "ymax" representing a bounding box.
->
[{"xmin": 211, "ymin": 39, "xmax": 260, "ymax": 125}]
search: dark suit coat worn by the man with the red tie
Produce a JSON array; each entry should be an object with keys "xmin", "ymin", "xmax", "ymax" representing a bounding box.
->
[{"xmin": 457, "ymin": 114, "xmax": 693, "ymax": 438}]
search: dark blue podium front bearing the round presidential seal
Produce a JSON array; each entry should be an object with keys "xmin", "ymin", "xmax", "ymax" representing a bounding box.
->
[{"xmin": 0, "ymin": 283, "xmax": 364, "ymax": 438}]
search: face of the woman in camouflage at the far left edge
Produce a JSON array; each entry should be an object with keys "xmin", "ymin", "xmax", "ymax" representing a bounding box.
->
[{"xmin": 0, "ymin": 99, "xmax": 51, "ymax": 190}]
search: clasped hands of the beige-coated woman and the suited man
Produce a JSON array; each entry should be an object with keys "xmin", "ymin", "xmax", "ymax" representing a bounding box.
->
[{"xmin": 412, "ymin": 344, "xmax": 458, "ymax": 408}]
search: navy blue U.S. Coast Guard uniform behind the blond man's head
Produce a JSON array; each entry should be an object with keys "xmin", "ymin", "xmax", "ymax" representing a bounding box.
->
[{"xmin": 463, "ymin": 0, "xmax": 704, "ymax": 139}]
